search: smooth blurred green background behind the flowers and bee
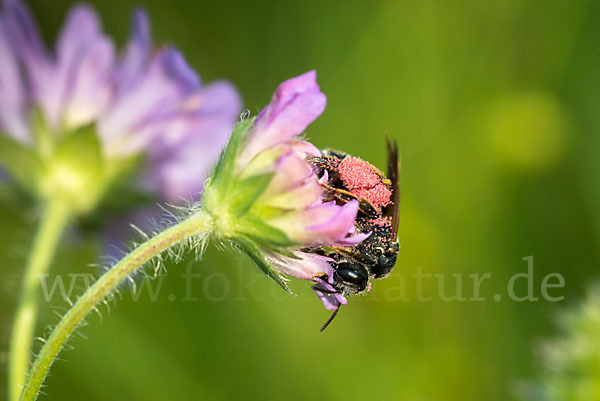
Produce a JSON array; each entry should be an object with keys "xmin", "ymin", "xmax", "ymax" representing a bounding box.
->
[{"xmin": 0, "ymin": 0, "xmax": 600, "ymax": 401}]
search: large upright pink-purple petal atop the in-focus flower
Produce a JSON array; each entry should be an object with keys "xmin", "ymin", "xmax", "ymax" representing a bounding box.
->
[{"xmin": 238, "ymin": 71, "xmax": 327, "ymax": 167}]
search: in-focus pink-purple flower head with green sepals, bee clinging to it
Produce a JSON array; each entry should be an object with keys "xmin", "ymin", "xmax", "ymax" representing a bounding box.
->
[{"xmin": 202, "ymin": 71, "xmax": 368, "ymax": 309}]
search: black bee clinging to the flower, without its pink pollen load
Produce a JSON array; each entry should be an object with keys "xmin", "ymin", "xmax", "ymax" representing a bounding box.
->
[{"xmin": 311, "ymin": 139, "xmax": 400, "ymax": 331}]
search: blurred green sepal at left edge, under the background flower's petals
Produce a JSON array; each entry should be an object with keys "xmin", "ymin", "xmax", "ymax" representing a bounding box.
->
[{"xmin": 0, "ymin": 133, "xmax": 42, "ymax": 192}]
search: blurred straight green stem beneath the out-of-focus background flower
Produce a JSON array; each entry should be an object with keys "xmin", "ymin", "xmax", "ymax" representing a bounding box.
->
[{"xmin": 8, "ymin": 202, "xmax": 70, "ymax": 401}]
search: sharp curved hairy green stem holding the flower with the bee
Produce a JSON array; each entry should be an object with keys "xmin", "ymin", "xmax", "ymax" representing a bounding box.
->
[{"xmin": 20, "ymin": 210, "xmax": 213, "ymax": 401}]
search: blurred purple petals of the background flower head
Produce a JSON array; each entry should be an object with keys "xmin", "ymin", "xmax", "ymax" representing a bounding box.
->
[{"xmin": 0, "ymin": 0, "xmax": 241, "ymax": 209}]
